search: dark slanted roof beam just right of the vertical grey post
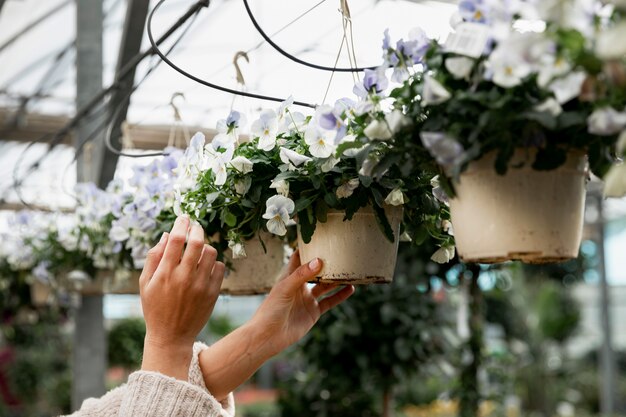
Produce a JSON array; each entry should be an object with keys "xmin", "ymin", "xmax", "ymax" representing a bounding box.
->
[{"xmin": 98, "ymin": 0, "xmax": 150, "ymax": 188}]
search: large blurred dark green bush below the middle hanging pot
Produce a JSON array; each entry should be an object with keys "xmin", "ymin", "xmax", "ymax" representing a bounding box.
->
[{"xmin": 279, "ymin": 241, "xmax": 449, "ymax": 417}]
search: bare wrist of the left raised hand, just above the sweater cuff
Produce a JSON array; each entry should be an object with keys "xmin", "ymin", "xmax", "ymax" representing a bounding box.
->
[{"xmin": 141, "ymin": 335, "xmax": 193, "ymax": 381}]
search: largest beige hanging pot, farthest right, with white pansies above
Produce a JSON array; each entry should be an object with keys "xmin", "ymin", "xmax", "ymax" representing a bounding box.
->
[{"xmin": 450, "ymin": 150, "xmax": 587, "ymax": 263}]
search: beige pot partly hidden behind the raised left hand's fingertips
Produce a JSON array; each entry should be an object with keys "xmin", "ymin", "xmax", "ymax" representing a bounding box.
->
[{"xmin": 220, "ymin": 233, "xmax": 285, "ymax": 295}]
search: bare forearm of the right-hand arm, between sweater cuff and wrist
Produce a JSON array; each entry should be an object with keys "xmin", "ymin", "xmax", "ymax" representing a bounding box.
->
[{"xmin": 200, "ymin": 322, "xmax": 278, "ymax": 401}]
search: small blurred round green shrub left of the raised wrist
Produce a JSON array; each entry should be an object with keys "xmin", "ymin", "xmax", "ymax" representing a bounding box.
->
[{"xmin": 107, "ymin": 318, "xmax": 146, "ymax": 369}]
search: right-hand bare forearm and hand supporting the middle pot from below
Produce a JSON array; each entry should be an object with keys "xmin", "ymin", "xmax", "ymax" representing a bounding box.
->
[{"xmin": 200, "ymin": 252, "xmax": 354, "ymax": 400}]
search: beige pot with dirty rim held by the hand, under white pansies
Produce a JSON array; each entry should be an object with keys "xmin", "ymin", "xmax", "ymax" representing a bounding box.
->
[{"xmin": 298, "ymin": 206, "xmax": 403, "ymax": 284}]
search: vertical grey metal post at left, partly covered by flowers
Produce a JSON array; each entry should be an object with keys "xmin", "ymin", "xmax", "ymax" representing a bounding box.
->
[{"xmin": 72, "ymin": 0, "xmax": 107, "ymax": 410}]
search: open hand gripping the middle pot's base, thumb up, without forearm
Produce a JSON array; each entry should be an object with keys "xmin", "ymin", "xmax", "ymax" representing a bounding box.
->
[{"xmin": 250, "ymin": 251, "xmax": 354, "ymax": 354}]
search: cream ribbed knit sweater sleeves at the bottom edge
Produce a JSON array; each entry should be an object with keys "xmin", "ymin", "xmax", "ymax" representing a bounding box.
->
[{"xmin": 63, "ymin": 342, "xmax": 235, "ymax": 417}]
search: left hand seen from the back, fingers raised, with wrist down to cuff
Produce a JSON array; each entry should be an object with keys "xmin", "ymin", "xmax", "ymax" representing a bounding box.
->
[{"xmin": 139, "ymin": 217, "xmax": 224, "ymax": 380}]
